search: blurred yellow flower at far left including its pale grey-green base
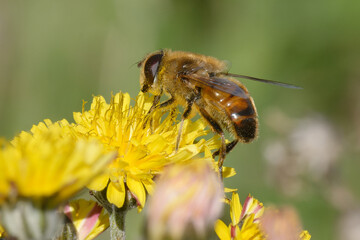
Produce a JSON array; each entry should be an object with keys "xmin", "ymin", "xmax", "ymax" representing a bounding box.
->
[{"xmin": 0, "ymin": 120, "xmax": 115, "ymax": 239}]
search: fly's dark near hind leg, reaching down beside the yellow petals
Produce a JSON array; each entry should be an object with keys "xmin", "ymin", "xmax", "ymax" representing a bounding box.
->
[{"xmin": 199, "ymin": 107, "xmax": 225, "ymax": 179}]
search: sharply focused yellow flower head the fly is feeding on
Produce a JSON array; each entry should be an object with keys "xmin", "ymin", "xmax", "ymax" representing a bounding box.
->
[{"xmin": 74, "ymin": 93, "xmax": 219, "ymax": 210}]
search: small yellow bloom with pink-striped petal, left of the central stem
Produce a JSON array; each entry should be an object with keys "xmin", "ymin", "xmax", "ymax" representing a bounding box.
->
[{"xmin": 64, "ymin": 199, "xmax": 109, "ymax": 240}]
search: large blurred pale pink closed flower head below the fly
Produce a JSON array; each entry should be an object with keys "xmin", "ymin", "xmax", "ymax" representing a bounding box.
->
[{"xmin": 147, "ymin": 159, "xmax": 224, "ymax": 239}]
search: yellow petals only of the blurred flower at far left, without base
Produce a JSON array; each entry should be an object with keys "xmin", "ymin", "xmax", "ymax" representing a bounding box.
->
[{"xmin": 0, "ymin": 120, "xmax": 114, "ymax": 207}]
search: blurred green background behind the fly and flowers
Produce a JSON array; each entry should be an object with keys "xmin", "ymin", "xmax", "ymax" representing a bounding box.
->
[{"xmin": 0, "ymin": 0, "xmax": 360, "ymax": 240}]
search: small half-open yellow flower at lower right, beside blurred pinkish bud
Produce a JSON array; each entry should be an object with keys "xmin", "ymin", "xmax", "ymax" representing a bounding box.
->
[{"xmin": 215, "ymin": 193, "xmax": 265, "ymax": 240}]
